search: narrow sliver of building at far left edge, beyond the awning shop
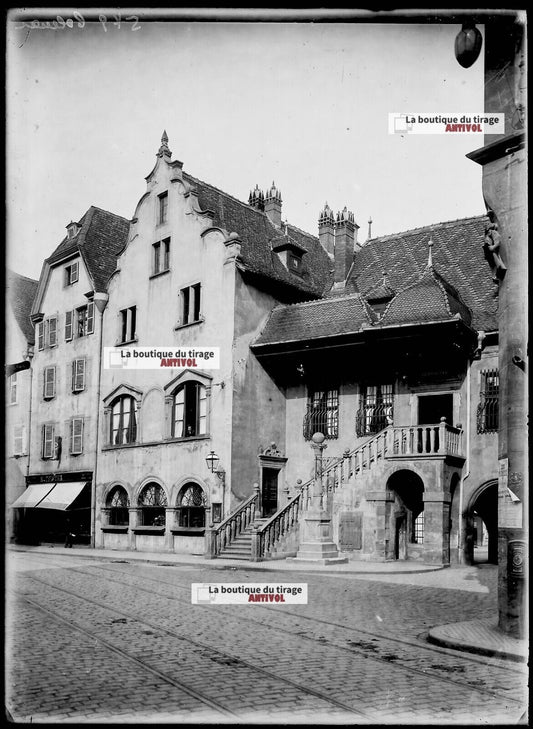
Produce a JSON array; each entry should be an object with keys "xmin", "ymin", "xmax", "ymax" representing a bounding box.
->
[{"xmin": 5, "ymin": 269, "xmax": 38, "ymax": 539}]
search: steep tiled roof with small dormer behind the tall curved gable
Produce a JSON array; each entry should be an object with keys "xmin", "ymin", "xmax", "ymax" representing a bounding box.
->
[{"xmin": 183, "ymin": 173, "xmax": 332, "ymax": 296}]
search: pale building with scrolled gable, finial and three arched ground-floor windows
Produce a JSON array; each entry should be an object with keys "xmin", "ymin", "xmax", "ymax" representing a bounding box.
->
[{"xmin": 96, "ymin": 134, "xmax": 331, "ymax": 552}]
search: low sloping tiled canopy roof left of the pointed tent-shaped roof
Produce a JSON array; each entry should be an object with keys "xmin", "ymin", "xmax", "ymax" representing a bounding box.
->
[{"xmin": 255, "ymin": 294, "xmax": 372, "ymax": 344}]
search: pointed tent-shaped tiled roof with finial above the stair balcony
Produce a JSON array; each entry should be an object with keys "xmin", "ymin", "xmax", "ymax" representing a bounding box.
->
[{"xmin": 380, "ymin": 266, "xmax": 472, "ymax": 326}]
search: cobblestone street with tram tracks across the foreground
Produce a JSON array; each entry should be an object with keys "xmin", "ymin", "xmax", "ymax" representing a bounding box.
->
[{"xmin": 6, "ymin": 551, "xmax": 526, "ymax": 724}]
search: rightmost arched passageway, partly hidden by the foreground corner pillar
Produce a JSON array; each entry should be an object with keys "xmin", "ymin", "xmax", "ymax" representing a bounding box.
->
[{"xmin": 465, "ymin": 481, "xmax": 498, "ymax": 564}]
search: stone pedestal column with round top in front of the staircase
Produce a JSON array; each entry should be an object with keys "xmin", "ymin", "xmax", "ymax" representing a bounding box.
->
[{"xmin": 289, "ymin": 433, "xmax": 348, "ymax": 565}]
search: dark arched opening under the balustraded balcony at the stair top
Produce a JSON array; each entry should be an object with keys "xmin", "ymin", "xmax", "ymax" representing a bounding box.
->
[{"xmin": 387, "ymin": 469, "xmax": 424, "ymax": 559}]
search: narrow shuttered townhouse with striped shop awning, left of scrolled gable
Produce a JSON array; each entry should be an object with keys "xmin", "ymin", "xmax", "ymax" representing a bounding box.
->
[{"xmin": 14, "ymin": 207, "xmax": 129, "ymax": 542}]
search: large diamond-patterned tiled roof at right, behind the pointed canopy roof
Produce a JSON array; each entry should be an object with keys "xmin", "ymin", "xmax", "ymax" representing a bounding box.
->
[{"xmin": 328, "ymin": 215, "xmax": 498, "ymax": 331}]
